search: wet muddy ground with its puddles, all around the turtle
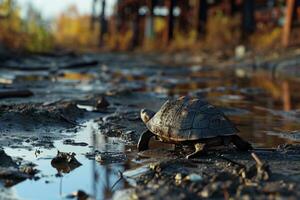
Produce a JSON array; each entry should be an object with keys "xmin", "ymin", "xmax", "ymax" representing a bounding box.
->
[{"xmin": 0, "ymin": 53, "xmax": 300, "ymax": 199}]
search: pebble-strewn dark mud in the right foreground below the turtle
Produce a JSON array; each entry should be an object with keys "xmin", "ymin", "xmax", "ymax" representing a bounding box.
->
[{"xmin": 119, "ymin": 151, "xmax": 300, "ymax": 199}]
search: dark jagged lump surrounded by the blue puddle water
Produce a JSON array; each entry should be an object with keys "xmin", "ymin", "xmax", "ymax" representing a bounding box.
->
[{"xmin": 51, "ymin": 151, "xmax": 81, "ymax": 173}]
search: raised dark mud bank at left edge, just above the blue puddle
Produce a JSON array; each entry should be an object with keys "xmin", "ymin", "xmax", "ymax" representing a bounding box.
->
[{"xmin": 0, "ymin": 102, "xmax": 84, "ymax": 148}]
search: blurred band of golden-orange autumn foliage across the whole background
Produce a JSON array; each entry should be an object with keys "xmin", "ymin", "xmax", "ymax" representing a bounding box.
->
[{"xmin": 0, "ymin": 0, "xmax": 281, "ymax": 52}]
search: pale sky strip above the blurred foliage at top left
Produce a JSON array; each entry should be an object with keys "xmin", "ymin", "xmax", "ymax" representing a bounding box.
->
[{"xmin": 16, "ymin": 0, "xmax": 116, "ymax": 18}]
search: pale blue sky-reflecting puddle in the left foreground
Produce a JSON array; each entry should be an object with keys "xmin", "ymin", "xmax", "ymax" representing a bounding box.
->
[{"xmin": 5, "ymin": 120, "xmax": 129, "ymax": 200}]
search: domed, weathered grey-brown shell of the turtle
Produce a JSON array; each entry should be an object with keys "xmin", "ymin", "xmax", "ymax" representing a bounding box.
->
[{"xmin": 146, "ymin": 97, "xmax": 238, "ymax": 142}]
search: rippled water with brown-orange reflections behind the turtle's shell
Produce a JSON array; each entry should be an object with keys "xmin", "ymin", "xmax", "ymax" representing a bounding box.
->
[{"xmin": 142, "ymin": 69, "xmax": 300, "ymax": 147}]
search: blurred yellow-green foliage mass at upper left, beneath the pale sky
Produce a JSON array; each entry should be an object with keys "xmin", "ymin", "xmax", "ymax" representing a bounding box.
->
[{"xmin": 0, "ymin": 0, "xmax": 98, "ymax": 52}]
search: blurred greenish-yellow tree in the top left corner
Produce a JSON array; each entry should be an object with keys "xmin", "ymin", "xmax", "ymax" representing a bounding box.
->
[{"xmin": 0, "ymin": 0, "xmax": 52, "ymax": 51}]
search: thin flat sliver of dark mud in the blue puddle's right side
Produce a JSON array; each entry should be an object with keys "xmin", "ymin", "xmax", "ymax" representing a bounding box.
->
[{"xmin": 86, "ymin": 150, "xmax": 128, "ymax": 164}]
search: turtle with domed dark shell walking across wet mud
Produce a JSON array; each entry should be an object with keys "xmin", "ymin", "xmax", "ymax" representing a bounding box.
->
[{"xmin": 137, "ymin": 96, "xmax": 252, "ymax": 159}]
